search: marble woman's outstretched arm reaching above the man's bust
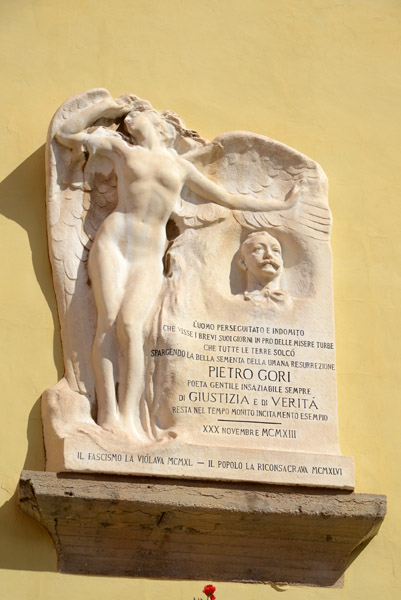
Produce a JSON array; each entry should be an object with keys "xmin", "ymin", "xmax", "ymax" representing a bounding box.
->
[{"xmin": 184, "ymin": 159, "xmax": 300, "ymax": 212}]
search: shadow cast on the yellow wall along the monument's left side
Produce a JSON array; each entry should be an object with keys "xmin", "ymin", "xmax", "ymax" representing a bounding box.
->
[{"xmin": 0, "ymin": 145, "xmax": 63, "ymax": 571}]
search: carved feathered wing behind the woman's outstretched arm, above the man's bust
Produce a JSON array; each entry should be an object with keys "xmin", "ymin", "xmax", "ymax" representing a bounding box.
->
[{"xmin": 181, "ymin": 131, "xmax": 331, "ymax": 240}]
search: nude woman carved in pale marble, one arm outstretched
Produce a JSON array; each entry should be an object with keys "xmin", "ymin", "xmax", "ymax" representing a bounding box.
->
[{"xmin": 56, "ymin": 98, "xmax": 296, "ymax": 443}]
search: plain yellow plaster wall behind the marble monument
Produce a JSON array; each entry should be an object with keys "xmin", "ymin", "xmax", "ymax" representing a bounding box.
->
[{"xmin": 0, "ymin": 0, "xmax": 401, "ymax": 600}]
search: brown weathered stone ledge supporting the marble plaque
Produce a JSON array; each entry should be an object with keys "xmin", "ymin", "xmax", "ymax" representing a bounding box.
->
[{"xmin": 19, "ymin": 471, "xmax": 386, "ymax": 587}]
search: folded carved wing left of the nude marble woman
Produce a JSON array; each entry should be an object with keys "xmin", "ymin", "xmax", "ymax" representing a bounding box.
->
[{"xmin": 46, "ymin": 89, "xmax": 117, "ymax": 399}]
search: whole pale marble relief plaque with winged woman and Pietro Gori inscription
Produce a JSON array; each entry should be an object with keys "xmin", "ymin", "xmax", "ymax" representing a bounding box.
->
[{"xmin": 42, "ymin": 89, "xmax": 352, "ymax": 487}]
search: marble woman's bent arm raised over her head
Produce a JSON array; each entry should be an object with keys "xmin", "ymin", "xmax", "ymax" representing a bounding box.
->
[{"xmin": 56, "ymin": 97, "xmax": 130, "ymax": 149}]
